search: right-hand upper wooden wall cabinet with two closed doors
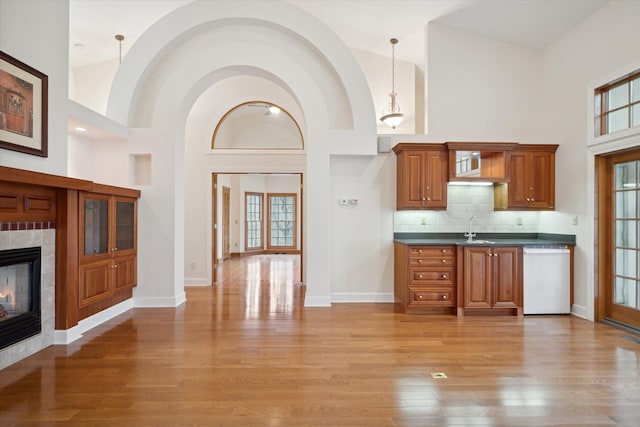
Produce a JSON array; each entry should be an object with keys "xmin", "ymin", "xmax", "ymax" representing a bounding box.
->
[{"xmin": 494, "ymin": 144, "xmax": 558, "ymax": 210}]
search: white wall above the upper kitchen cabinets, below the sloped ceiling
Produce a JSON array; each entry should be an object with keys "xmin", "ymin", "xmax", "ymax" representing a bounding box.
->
[{"xmin": 427, "ymin": 23, "xmax": 553, "ymax": 143}]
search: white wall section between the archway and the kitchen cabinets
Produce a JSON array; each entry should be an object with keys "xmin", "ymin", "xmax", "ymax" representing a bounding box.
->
[{"xmin": 332, "ymin": 153, "xmax": 396, "ymax": 302}]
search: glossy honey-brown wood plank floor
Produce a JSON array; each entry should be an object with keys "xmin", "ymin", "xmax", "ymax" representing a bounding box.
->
[{"xmin": 0, "ymin": 255, "xmax": 640, "ymax": 427}]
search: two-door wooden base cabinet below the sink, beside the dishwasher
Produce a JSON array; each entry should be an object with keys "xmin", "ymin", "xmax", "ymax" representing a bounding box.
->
[{"xmin": 458, "ymin": 246, "xmax": 522, "ymax": 315}]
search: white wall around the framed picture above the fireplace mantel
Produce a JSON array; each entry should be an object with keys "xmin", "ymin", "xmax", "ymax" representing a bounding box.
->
[{"xmin": 0, "ymin": 0, "xmax": 69, "ymax": 175}]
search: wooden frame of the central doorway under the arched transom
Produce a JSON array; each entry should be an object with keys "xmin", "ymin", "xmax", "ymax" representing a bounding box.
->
[{"xmin": 209, "ymin": 171, "xmax": 305, "ymax": 285}]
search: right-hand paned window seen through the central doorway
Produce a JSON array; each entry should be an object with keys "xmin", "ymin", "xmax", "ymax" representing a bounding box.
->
[{"xmin": 268, "ymin": 193, "xmax": 297, "ymax": 248}]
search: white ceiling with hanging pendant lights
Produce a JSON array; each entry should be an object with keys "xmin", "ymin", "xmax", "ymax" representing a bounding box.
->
[{"xmin": 69, "ymin": 0, "xmax": 607, "ymax": 67}]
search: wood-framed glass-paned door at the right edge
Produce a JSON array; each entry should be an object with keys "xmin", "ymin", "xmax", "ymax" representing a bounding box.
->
[{"xmin": 598, "ymin": 148, "xmax": 640, "ymax": 328}]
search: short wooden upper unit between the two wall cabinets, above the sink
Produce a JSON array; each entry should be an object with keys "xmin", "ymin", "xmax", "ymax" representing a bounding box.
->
[{"xmin": 446, "ymin": 142, "xmax": 518, "ymax": 182}]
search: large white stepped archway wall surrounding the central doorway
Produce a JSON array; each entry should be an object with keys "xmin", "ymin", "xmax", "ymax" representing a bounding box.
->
[{"xmin": 105, "ymin": 2, "xmax": 376, "ymax": 306}]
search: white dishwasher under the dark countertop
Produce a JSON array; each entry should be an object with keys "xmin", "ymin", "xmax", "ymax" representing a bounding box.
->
[{"xmin": 522, "ymin": 247, "xmax": 571, "ymax": 314}]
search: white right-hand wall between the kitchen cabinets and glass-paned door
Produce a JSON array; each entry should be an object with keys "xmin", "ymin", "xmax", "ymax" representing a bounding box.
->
[{"xmin": 540, "ymin": 0, "xmax": 640, "ymax": 318}]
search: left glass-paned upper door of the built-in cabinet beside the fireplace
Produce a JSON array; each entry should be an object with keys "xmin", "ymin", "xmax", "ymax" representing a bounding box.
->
[{"xmin": 83, "ymin": 199, "xmax": 109, "ymax": 255}]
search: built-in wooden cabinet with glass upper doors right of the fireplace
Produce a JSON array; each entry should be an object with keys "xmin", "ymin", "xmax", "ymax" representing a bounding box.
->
[{"xmin": 78, "ymin": 193, "xmax": 137, "ymax": 309}]
